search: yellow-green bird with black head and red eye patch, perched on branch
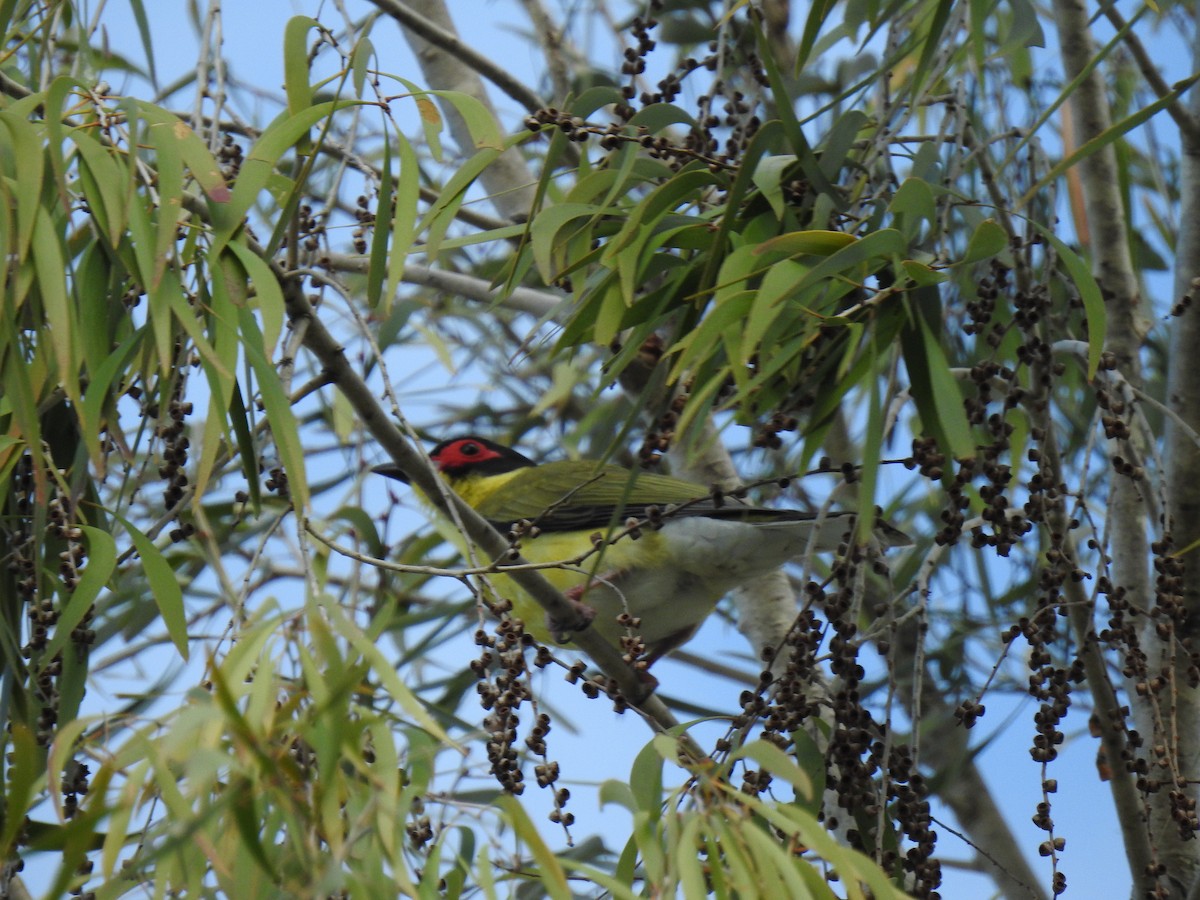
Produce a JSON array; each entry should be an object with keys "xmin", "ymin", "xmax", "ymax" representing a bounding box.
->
[{"xmin": 372, "ymin": 434, "xmax": 912, "ymax": 667}]
